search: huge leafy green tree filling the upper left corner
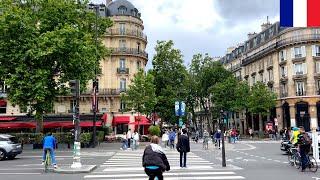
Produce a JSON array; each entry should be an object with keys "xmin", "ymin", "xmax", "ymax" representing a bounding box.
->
[{"xmin": 0, "ymin": 0, "xmax": 112, "ymax": 132}]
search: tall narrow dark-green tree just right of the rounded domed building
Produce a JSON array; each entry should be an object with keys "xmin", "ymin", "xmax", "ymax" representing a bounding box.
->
[{"xmin": 152, "ymin": 40, "xmax": 187, "ymax": 124}]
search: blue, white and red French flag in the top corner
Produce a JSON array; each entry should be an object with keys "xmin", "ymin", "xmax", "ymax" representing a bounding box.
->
[{"xmin": 280, "ymin": 0, "xmax": 320, "ymax": 27}]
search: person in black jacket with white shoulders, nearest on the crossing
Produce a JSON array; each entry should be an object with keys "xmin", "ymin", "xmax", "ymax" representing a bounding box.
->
[{"xmin": 142, "ymin": 136, "xmax": 170, "ymax": 180}]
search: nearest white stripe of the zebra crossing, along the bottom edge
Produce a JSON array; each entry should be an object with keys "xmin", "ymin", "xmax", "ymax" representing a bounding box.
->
[{"xmin": 84, "ymin": 172, "xmax": 235, "ymax": 179}]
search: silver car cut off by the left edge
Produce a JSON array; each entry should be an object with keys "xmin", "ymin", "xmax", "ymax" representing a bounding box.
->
[{"xmin": 0, "ymin": 134, "xmax": 22, "ymax": 161}]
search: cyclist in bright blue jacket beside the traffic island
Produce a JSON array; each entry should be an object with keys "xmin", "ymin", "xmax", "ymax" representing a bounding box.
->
[{"xmin": 42, "ymin": 132, "xmax": 58, "ymax": 168}]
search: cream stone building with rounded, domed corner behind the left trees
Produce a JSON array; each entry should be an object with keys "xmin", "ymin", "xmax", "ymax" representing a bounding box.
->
[{"xmin": 0, "ymin": 0, "xmax": 148, "ymax": 133}]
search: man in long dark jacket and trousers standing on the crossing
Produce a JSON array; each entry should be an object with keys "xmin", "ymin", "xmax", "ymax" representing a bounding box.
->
[{"xmin": 177, "ymin": 129, "xmax": 190, "ymax": 167}]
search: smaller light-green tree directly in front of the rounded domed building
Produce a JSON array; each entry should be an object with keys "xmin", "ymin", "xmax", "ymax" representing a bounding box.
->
[{"xmin": 122, "ymin": 70, "xmax": 157, "ymax": 120}]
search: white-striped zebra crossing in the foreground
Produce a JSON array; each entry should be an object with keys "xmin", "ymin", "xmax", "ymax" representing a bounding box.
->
[{"xmin": 84, "ymin": 150, "xmax": 245, "ymax": 180}]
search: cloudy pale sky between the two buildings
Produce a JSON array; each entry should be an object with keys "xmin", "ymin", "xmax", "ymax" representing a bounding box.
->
[{"xmin": 93, "ymin": 0, "xmax": 280, "ymax": 69}]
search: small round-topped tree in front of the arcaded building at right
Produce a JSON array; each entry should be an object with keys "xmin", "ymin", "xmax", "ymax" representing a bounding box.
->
[{"xmin": 248, "ymin": 82, "xmax": 277, "ymax": 131}]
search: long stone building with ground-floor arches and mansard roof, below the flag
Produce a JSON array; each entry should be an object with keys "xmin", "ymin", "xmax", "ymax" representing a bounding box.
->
[{"xmin": 220, "ymin": 22, "xmax": 320, "ymax": 132}]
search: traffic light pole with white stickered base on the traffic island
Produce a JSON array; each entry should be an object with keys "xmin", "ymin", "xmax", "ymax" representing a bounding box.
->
[{"xmin": 69, "ymin": 80, "xmax": 82, "ymax": 168}]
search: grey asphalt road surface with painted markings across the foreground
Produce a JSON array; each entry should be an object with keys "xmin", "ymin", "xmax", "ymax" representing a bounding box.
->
[{"xmin": 0, "ymin": 141, "xmax": 320, "ymax": 180}]
